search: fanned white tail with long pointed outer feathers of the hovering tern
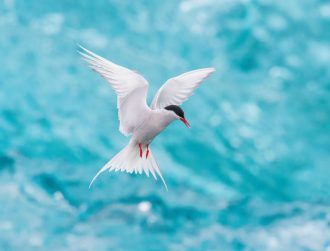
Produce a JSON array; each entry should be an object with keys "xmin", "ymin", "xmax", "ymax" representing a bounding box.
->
[{"xmin": 89, "ymin": 143, "xmax": 168, "ymax": 190}]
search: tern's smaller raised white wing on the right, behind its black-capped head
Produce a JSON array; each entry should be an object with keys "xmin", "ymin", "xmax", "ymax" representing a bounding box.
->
[{"xmin": 151, "ymin": 68, "xmax": 215, "ymax": 109}]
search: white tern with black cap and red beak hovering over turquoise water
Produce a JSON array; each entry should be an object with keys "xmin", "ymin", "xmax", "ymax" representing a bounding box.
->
[{"xmin": 78, "ymin": 45, "xmax": 215, "ymax": 190}]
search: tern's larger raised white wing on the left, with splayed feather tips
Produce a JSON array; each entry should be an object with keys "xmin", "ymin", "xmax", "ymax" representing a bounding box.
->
[{"xmin": 79, "ymin": 46, "xmax": 150, "ymax": 136}]
